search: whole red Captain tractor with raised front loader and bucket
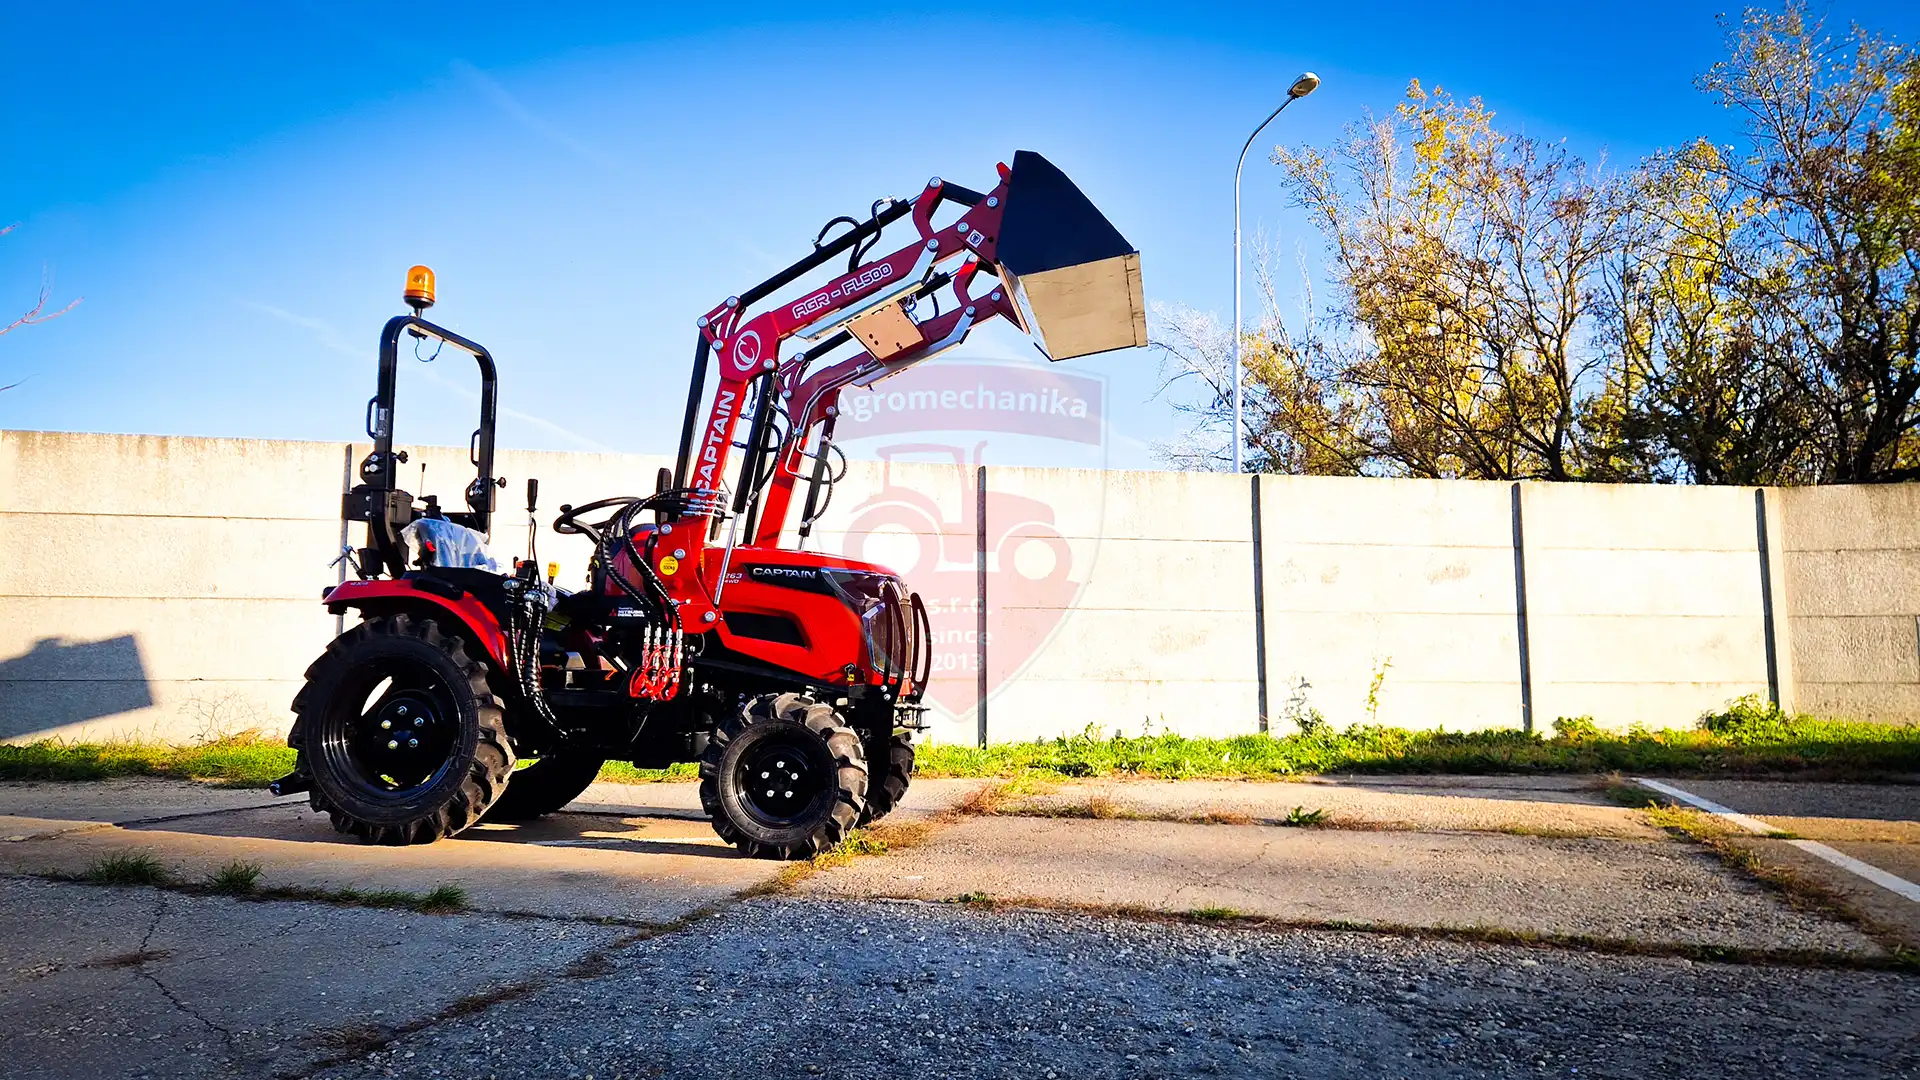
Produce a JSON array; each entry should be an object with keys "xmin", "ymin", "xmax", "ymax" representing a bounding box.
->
[{"xmin": 273, "ymin": 150, "xmax": 1146, "ymax": 859}]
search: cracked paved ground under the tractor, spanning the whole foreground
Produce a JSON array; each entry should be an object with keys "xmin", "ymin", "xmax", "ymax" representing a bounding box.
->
[{"xmin": 0, "ymin": 778, "xmax": 1920, "ymax": 1080}]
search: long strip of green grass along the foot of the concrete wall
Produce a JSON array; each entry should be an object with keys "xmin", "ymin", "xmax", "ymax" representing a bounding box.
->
[{"xmin": 15, "ymin": 698, "xmax": 1920, "ymax": 788}]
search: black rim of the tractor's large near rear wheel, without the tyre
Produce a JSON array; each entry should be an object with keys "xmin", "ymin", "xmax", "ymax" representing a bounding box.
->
[{"xmin": 321, "ymin": 661, "xmax": 461, "ymax": 801}]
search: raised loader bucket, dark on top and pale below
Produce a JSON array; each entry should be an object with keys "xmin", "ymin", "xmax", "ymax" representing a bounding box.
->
[{"xmin": 996, "ymin": 150, "xmax": 1146, "ymax": 359}]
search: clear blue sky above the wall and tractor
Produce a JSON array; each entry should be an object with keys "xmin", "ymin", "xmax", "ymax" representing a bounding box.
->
[{"xmin": 0, "ymin": 0, "xmax": 1920, "ymax": 467}]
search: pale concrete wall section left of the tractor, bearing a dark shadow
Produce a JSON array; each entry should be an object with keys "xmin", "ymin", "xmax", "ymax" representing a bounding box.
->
[{"xmin": 0, "ymin": 432, "xmax": 348, "ymax": 740}]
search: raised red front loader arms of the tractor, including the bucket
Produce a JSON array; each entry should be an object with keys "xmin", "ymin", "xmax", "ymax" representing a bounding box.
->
[{"xmin": 674, "ymin": 150, "xmax": 1146, "ymax": 564}]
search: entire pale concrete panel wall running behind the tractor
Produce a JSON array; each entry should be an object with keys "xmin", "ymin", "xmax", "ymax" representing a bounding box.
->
[{"xmin": 0, "ymin": 424, "xmax": 1920, "ymax": 742}]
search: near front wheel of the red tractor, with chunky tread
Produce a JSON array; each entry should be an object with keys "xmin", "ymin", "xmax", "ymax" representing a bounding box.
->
[{"xmin": 701, "ymin": 694, "xmax": 866, "ymax": 859}]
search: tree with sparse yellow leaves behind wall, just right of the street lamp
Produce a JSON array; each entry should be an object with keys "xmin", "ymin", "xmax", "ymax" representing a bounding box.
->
[{"xmin": 1252, "ymin": 83, "xmax": 1638, "ymax": 480}]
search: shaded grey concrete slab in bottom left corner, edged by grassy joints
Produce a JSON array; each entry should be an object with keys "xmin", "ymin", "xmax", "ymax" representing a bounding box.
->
[{"xmin": 0, "ymin": 878, "xmax": 630, "ymax": 1080}]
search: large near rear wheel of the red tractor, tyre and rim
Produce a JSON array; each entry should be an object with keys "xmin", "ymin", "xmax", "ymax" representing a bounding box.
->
[{"xmin": 294, "ymin": 615, "xmax": 515, "ymax": 846}]
